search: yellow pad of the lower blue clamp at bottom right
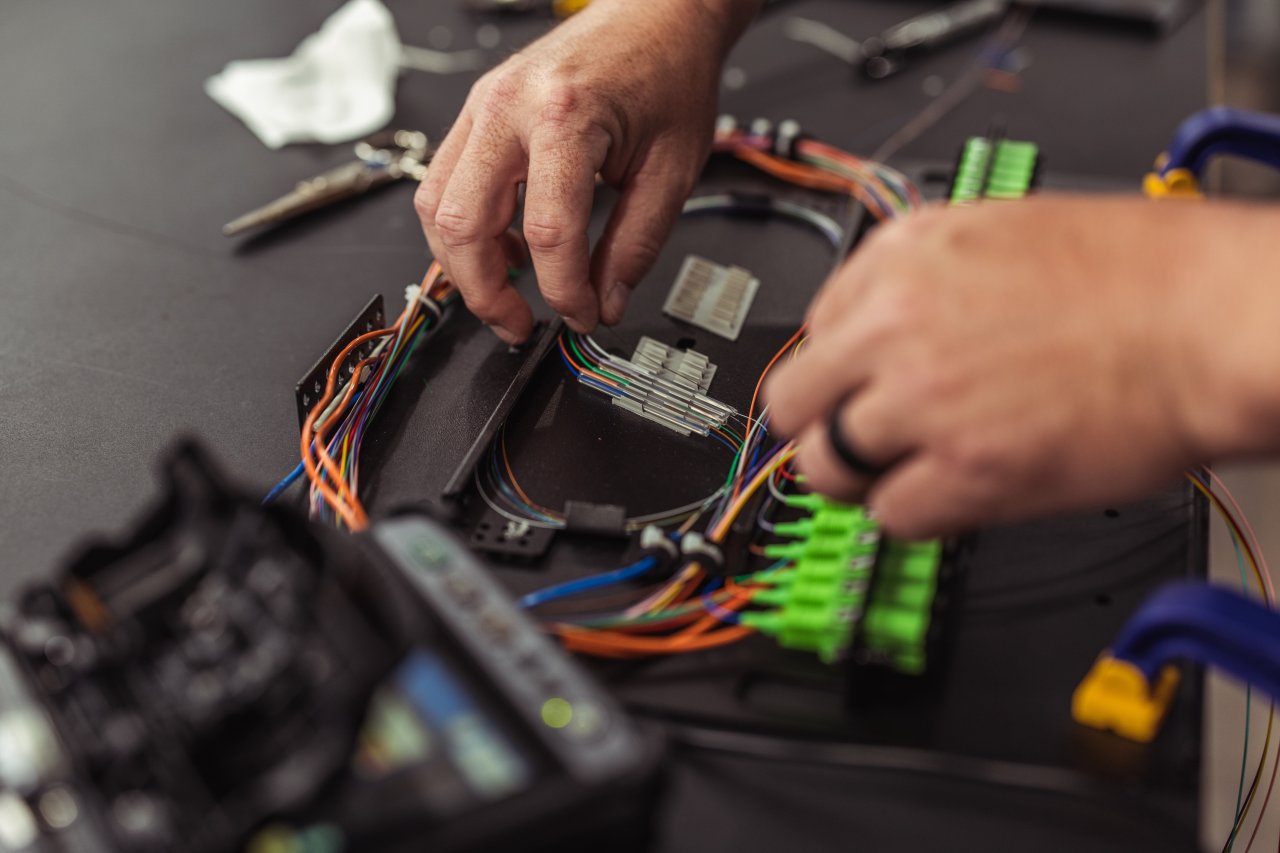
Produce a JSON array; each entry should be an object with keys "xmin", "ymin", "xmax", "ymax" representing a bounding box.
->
[{"xmin": 1071, "ymin": 652, "xmax": 1180, "ymax": 743}]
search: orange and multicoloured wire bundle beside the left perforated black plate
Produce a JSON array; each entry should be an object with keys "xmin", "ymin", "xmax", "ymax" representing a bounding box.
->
[{"xmin": 276, "ymin": 264, "xmax": 457, "ymax": 530}]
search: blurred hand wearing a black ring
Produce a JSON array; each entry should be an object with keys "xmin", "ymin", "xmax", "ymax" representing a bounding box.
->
[{"xmin": 765, "ymin": 197, "xmax": 1280, "ymax": 537}]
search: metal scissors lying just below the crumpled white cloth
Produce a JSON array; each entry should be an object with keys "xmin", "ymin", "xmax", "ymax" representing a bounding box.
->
[{"xmin": 223, "ymin": 131, "xmax": 434, "ymax": 237}]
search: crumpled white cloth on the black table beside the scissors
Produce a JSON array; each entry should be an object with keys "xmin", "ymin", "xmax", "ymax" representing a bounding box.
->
[{"xmin": 205, "ymin": 0, "xmax": 401, "ymax": 149}]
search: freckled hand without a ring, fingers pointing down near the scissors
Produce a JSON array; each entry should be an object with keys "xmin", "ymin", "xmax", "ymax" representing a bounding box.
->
[{"xmin": 415, "ymin": 0, "xmax": 759, "ymax": 343}]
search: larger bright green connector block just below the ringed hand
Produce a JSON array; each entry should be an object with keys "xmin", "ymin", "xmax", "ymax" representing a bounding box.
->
[{"xmin": 741, "ymin": 494, "xmax": 942, "ymax": 675}]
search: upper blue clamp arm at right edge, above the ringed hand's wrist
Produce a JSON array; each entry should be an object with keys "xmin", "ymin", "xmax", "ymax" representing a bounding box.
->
[{"xmin": 1160, "ymin": 106, "xmax": 1280, "ymax": 178}]
